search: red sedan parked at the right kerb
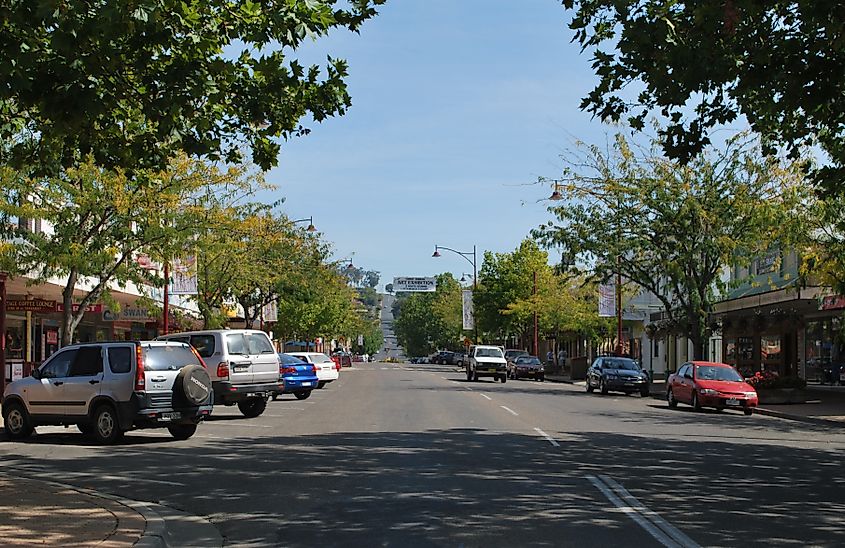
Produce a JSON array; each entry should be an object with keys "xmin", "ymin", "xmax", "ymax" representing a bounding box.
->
[{"xmin": 666, "ymin": 362, "xmax": 757, "ymax": 415}]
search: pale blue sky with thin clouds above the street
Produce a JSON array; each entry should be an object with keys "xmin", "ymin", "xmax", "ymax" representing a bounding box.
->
[{"xmin": 266, "ymin": 0, "xmax": 613, "ymax": 287}]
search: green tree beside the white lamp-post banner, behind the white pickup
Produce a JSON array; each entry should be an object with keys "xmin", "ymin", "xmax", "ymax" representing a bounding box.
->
[{"xmin": 473, "ymin": 239, "xmax": 551, "ymax": 347}]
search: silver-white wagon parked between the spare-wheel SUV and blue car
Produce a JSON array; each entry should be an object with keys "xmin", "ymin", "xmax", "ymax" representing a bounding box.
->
[{"xmin": 162, "ymin": 329, "xmax": 284, "ymax": 417}]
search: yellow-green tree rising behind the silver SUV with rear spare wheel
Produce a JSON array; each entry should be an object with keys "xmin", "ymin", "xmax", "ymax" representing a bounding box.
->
[{"xmin": 0, "ymin": 157, "xmax": 213, "ymax": 346}]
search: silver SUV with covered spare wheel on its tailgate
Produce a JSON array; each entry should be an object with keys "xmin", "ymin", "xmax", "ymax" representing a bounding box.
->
[{"xmin": 3, "ymin": 341, "xmax": 212, "ymax": 444}]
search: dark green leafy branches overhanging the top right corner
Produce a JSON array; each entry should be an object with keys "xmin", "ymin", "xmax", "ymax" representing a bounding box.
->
[{"xmin": 562, "ymin": 0, "xmax": 845, "ymax": 191}]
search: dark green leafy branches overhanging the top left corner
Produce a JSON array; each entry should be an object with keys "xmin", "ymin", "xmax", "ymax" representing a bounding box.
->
[{"xmin": 0, "ymin": 0, "xmax": 385, "ymax": 175}]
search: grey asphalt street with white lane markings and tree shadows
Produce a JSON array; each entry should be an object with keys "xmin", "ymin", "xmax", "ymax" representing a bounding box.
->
[{"xmin": 0, "ymin": 363, "xmax": 845, "ymax": 548}]
